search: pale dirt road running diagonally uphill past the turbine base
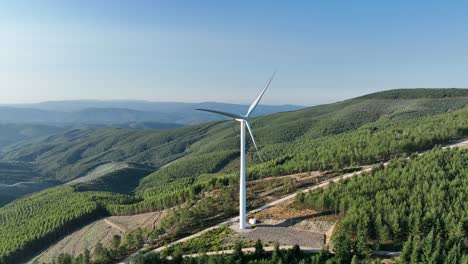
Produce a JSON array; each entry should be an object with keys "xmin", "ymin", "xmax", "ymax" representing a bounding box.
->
[{"xmin": 119, "ymin": 140, "xmax": 468, "ymax": 264}]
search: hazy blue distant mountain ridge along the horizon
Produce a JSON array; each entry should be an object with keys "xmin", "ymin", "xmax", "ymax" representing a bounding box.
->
[{"xmin": 0, "ymin": 101, "xmax": 304, "ymax": 127}]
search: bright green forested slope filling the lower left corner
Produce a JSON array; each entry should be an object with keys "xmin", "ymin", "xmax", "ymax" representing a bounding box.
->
[{"xmin": 0, "ymin": 186, "xmax": 133, "ymax": 263}]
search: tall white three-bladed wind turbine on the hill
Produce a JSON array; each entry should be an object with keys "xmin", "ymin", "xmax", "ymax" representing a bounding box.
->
[{"xmin": 197, "ymin": 72, "xmax": 276, "ymax": 230}]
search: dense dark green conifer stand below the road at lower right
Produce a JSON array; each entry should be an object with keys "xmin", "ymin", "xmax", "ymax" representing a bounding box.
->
[{"xmin": 296, "ymin": 148, "xmax": 468, "ymax": 264}]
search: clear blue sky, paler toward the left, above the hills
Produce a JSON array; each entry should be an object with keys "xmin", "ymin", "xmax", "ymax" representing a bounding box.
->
[{"xmin": 0, "ymin": 0, "xmax": 468, "ymax": 105}]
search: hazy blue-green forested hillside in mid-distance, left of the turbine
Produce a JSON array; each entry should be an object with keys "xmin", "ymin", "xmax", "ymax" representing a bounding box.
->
[{"xmin": 3, "ymin": 124, "xmax": 224, "ymax": 182}]
